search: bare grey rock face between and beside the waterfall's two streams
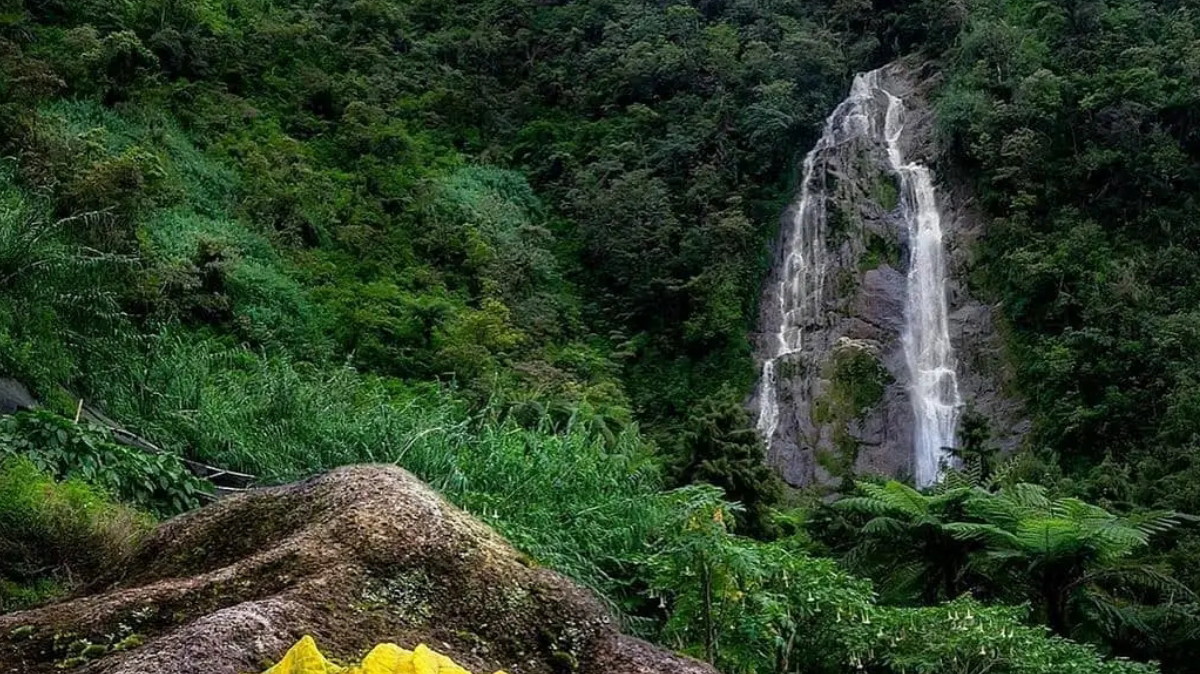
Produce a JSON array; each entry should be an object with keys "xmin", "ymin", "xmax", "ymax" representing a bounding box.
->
[{"xmin": 750, "ymin": 64, "xmax": 1027, "ymax": 487}]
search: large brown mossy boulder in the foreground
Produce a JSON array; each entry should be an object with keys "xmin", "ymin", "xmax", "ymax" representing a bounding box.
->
[{"xmin": 0, "ymin": 467, "xmax": 714, "ymax": 674}]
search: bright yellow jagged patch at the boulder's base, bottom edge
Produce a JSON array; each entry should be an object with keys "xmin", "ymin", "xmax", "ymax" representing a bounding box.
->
[{"xmin": 263, "ymin": 636, "xmax": 505, "ymax": 674}]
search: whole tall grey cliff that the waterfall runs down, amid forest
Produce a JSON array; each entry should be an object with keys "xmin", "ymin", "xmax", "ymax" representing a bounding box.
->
[{"xmin": 750, "ymin": 64, "xmax": 1027, "ymax": 486}]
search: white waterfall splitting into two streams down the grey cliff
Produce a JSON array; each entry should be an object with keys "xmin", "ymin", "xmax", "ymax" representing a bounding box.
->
[{"xmin": 757, "ymin": 70, "xmax": 961, "ymax": 487}]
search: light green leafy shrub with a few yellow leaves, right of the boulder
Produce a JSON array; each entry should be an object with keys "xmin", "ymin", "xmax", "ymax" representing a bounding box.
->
[{"xmin": 648, "ymin": 488, "xmax": 871, "ymax": 673}]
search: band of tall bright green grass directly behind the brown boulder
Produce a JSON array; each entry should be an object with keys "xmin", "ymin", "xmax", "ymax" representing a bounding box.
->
[{"xmin": 81, "ymin": 332, "xmax": 670, "ymax": 596}]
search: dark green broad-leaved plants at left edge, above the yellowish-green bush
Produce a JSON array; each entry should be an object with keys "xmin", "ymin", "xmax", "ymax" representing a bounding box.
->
[{"xmin": 0, "ymin": 411, "xmax": 211, "ymax": 514}]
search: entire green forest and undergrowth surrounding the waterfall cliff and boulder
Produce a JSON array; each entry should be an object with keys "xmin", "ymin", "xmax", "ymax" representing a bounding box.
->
[{"xmin": 0, "ymin": 0, "xmax": 1200, "ymax": 674}]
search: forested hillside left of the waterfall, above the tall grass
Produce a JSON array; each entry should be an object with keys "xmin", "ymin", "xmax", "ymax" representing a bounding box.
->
[{"xmin": 4, "ymin": 2, "xmax": 892, "ymax": 436}]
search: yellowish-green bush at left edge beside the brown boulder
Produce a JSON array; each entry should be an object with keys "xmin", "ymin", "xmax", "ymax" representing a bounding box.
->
[{"xmin": 0, "ymin": 458, "xmax": 149, "ymax": 610}]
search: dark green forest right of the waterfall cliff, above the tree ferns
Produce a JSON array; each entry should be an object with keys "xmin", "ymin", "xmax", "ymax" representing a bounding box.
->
[{"xmin": 924, "ymin": 0, "xmax": 1200, "ymax": 672}]
